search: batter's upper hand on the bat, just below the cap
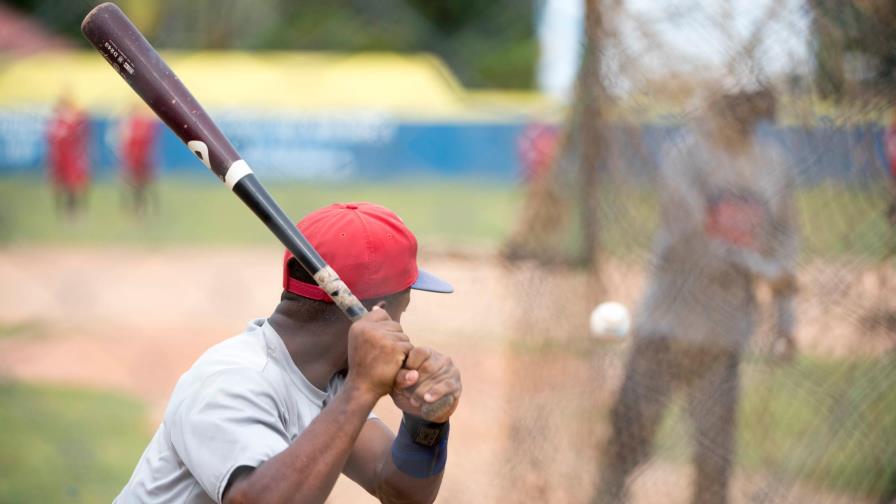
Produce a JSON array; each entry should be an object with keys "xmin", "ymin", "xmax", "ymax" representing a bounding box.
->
[{"xmin": 346, "ymin": 305, "xmax": 413, "ymax": 398}]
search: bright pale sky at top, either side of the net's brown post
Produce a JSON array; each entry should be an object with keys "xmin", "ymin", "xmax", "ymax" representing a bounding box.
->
[{"xmin": 536, "ymin": 0, "xmax": 811, "ymax": 101}]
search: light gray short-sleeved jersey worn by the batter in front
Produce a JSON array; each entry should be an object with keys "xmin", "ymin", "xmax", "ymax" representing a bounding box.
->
[{"xmin": 115, "ymin": 319, "xmax": 374, "ymax": 503}]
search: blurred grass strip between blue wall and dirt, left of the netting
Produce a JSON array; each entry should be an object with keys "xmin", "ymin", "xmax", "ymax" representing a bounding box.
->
[{"xmin": 0, "ymin": 178, "xmax": 519, "ymax": 246}]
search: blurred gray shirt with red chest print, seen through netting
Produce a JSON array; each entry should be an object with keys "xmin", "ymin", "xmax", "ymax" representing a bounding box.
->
[{"xmin": 635, "ymin": 124, "xmax": 797, "ymax": 349}]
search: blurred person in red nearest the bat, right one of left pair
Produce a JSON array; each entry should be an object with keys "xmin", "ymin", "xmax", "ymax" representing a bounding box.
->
[{"xmin": 119, "ymin": 106, "xmax": 158, "ymax": 216}]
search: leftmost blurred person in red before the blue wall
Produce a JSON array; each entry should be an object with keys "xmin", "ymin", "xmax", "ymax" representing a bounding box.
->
[{"xmin": 47, "ymin": 94, "xmax": 90, "ymax": 218}]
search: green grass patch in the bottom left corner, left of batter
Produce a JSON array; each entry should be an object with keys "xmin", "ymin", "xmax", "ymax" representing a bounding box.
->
[{"xmin": 0, "ymin": 382, "xmax": 151, "ymax": 503}]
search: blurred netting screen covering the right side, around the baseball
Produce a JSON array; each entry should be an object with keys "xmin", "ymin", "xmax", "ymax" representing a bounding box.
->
[{"xmin": 504, "ymin": 1, "xmax": 896, "ymax": 502}]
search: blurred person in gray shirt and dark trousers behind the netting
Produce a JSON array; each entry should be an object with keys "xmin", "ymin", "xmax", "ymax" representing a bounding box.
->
[{"xmin": 596, "ymin": 91, "xmax": 797, "ymax": 503}]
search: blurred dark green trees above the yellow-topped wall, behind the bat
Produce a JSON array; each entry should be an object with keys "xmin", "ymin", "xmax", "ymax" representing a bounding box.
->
[{"xmin": 8, "ymin": 0, "xmax": 537, "ymax": 88}]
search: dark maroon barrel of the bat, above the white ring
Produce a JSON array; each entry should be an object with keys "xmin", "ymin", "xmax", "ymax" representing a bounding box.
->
[{"xmin": 81, "ymin": 3, "xmax": 240, "ymax": 180}]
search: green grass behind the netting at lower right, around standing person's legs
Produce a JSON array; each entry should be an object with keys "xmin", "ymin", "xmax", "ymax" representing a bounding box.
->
[{"xmin": 658, "ymin": 356, "xmax": 896, "ymax": 497}]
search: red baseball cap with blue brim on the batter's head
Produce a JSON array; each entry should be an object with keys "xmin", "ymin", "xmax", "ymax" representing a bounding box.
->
[{"xmin": 283, "ymin": 203, "xmax": 454, "ymax": 303}]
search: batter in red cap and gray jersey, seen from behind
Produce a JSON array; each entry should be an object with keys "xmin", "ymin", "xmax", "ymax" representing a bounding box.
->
[{"xmin": 116, "ymin": 203, "xmax": 461, "ymax": 503}]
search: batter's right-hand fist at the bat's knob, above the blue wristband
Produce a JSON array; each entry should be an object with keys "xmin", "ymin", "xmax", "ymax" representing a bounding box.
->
[{"xmin": 390, "ymin": 347, "xmax": 463, "ymax": 423}]
